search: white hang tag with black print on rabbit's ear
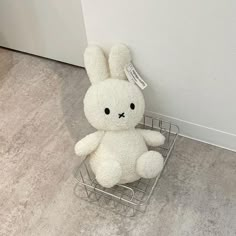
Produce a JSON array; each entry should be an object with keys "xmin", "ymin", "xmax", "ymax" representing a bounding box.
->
[{"xmin": 124, "ymin": 63, "xmax": 147, "ymax": 89}]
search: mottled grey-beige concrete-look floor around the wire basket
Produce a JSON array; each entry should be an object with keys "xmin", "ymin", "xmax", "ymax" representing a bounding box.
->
[{"xmin": 0, "ymin": 48, "xmax": 236, "ymax": 236}]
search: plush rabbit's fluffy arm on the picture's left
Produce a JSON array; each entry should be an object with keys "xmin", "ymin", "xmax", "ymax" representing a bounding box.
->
[{"xmin": 75, "ymin": 131, "xmax": 104, "ymax": 156}]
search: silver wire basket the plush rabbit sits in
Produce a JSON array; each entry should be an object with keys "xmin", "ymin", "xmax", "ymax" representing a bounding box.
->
[{"xmin": 74, "ymin": 115, "xmax": 179, "ymax": 216}]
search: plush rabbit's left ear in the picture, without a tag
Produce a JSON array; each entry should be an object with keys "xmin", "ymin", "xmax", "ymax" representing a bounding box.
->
[{"xmin": 84, "ymin": 45, "xmax": 109, "ymax": 84}]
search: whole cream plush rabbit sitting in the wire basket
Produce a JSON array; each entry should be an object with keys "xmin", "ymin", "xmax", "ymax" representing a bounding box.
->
[{"xmin": 75, "ymin": 44, "xmax": 165, "ymax": 188}]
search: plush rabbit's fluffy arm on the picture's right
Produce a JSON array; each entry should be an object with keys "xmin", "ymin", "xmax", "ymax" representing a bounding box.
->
[{"xmin": 137, "ymin": 129, "xmax": 165, "ymax": 147}]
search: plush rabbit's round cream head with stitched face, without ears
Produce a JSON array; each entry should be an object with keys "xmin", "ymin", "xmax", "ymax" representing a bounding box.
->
[{"xmin": 84, "ymin": 78, "xmax": 145, "ymax": 130}]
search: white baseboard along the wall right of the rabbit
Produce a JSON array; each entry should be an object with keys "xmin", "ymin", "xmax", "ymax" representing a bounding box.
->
[{"xmin": 146, "ymin": 111, "xmax": 236, "ymax": 152}]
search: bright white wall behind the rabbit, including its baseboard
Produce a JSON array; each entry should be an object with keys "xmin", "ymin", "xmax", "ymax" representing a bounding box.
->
[{"xmin": 82, "ymin": 0, "xmax": 236, "ymax": 150}]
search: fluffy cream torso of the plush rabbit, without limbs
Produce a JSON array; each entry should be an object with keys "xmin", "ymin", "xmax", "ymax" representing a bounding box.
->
[{"xmin": 90, "ymin": 128, "xmax": 148, "ymax": 185}]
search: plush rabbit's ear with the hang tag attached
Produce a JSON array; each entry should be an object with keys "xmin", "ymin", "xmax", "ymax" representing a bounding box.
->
[{"xmin": 109, "ymin": 44, "xmax": 131, "ymax": 79}]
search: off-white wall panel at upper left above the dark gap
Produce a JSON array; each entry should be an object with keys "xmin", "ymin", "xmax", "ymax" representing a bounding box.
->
[{"xmin": 0, "ymin": 0, "xmax": 87, "ymax": 66}]
